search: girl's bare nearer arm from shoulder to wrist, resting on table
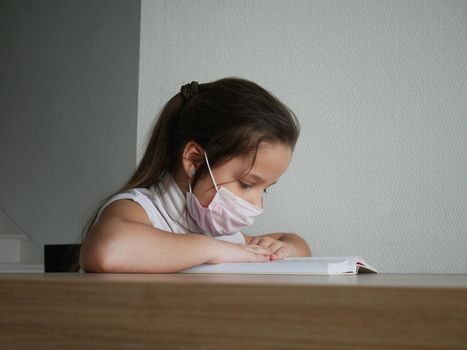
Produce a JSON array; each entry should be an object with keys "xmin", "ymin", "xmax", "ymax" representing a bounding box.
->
[{"xmin": 80, "ymin": 200, "xmax": 219, "ymax": 273}]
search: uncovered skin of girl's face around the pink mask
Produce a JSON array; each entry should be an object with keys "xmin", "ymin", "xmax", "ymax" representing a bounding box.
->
[{"xmin": 193, "ymin": 142, "xmax": 292, "ymax": 208}]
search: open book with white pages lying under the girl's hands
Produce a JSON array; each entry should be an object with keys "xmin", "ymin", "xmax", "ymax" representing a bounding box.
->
[{"xmin": 179, "ymin": 256, "xmax": 378, "ymax": 275}]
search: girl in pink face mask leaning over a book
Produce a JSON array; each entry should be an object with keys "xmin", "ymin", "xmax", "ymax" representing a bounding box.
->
[{"xmin": 79, "ymin": 78, "xmax": 311, "ymax": 273}]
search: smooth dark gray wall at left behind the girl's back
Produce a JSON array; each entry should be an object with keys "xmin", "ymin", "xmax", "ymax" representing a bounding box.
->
[{"xmin": 0, "ymin": 0, "xmax": 140, "ymax": 249}]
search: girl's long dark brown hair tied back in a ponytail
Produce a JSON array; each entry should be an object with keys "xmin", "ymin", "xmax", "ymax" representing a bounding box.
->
[{"xmin": 73, "ymin": 77, "xmax": 299, "ymax": 270}]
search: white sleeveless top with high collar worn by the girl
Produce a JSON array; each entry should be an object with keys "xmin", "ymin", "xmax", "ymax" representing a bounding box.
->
[{"xmin": 93, "ymin": 174, "xmax": 246, "ymax": 244}]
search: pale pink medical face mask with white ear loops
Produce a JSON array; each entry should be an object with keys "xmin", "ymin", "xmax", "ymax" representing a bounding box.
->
[{"xmin": 186, "ymin": 152, "xmax": 263, "ymax": 237}]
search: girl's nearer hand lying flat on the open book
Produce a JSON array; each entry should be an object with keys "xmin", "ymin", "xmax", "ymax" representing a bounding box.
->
[{"xmin": 206, "ymin": 239, "xmax": 272, "ymax": 264}]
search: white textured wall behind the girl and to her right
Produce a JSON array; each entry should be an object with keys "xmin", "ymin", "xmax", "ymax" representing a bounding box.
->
[{"xmin": 137, "ymin": 0, "xmax": 467, "ymax": 273}]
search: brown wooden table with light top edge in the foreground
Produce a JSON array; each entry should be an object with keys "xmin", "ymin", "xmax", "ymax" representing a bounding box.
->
[{"xmin": 0, "ymin": 273, "xmax": 467, "ymax": 350}]
